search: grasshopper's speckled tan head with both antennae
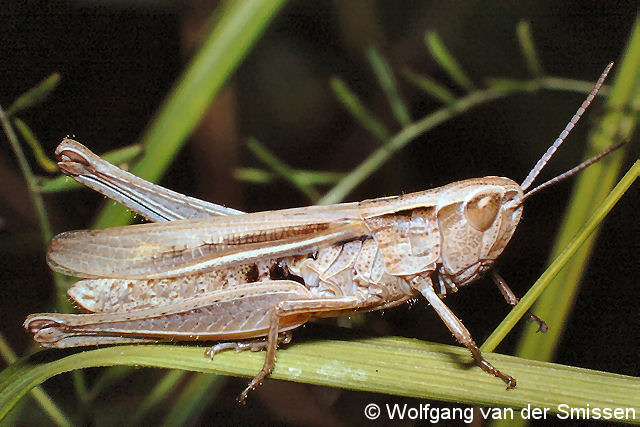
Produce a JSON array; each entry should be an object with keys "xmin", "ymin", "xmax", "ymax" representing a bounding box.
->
[{"xmin": 437, "ymin": 63, "xmax": 623, "ymax": 294}]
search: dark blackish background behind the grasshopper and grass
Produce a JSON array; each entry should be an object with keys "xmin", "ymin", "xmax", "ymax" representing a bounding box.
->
[{"xmin": 0, "ymin": 1, "xmax": 640, "ymax": 424}]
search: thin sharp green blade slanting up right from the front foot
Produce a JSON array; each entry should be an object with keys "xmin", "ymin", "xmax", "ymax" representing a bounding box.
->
[{"xmin": 480, "ymin": 160, "xmax": 640, "ymax": 351}]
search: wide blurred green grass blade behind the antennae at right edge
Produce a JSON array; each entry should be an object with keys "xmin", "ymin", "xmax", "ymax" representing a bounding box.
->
[{"xmin": 516, "ymin": 16, "xmax": 640, "ymax": 360}]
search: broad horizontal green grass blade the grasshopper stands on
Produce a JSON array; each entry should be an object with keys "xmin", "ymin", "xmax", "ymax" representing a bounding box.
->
[{"xmin": 0, "ymin": 337, "xmax": 640, "ymax": 422}]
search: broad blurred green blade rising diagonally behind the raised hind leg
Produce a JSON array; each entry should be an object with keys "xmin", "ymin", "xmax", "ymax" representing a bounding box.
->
[{"xmin": 94, "ymin": 0, "xmax": 285, "ymax": 228}]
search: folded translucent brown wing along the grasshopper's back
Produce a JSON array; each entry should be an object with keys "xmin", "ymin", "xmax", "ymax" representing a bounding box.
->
[{"xmin": 47, "ymin": 203, "xmax": 368, "ymax": 279}]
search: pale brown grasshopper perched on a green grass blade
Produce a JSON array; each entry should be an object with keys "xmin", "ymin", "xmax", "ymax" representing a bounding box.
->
[{"xmin": 24, "ymin": 63, "xmax": 621, "ymax": 401}]
